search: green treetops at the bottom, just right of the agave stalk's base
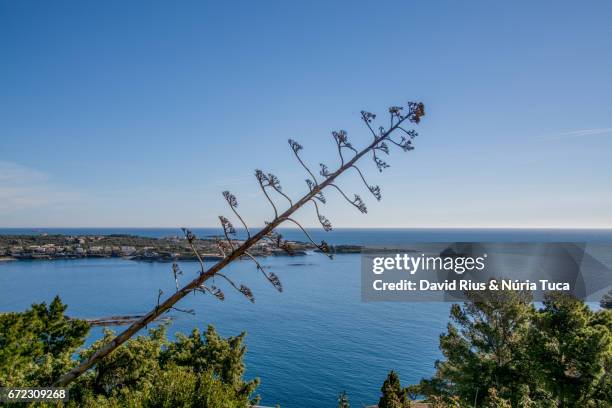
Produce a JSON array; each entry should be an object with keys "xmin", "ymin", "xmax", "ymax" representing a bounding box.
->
[{"xmin": 71, "ymin": 326, "xmax": 259, "ymax": 408}]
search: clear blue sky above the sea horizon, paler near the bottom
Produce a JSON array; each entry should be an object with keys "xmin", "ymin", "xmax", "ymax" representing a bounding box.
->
[{"xmin": 0, "ymin": 0, "xmax": 612, "ymax": 227}]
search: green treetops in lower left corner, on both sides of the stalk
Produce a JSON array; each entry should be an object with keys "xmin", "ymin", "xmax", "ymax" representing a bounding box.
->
[{"xmin": 0, "ymin": 298, "xmax": 259, "ymax": 408}]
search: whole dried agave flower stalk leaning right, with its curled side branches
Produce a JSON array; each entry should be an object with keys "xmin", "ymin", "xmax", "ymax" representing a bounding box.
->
[{"xmin": 54, "ymin": 102, "xmax": 425, "ymax": 387}]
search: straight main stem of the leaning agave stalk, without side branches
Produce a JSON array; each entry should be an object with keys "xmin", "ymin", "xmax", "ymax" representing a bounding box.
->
[{"xmin": 54, "ymin": 105, "xmax": 424, "ymax": 387}]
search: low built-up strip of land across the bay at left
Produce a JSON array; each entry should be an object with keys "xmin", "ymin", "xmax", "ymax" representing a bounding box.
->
[{"xmin": 0, "ymin": 234, "xmax": 315, "ymax": 262}]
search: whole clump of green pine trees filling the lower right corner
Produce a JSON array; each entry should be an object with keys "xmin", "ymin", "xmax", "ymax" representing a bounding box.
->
[{"xmin": 411, "ymin": 291, "xmax": 612, "ymax": 408}]
